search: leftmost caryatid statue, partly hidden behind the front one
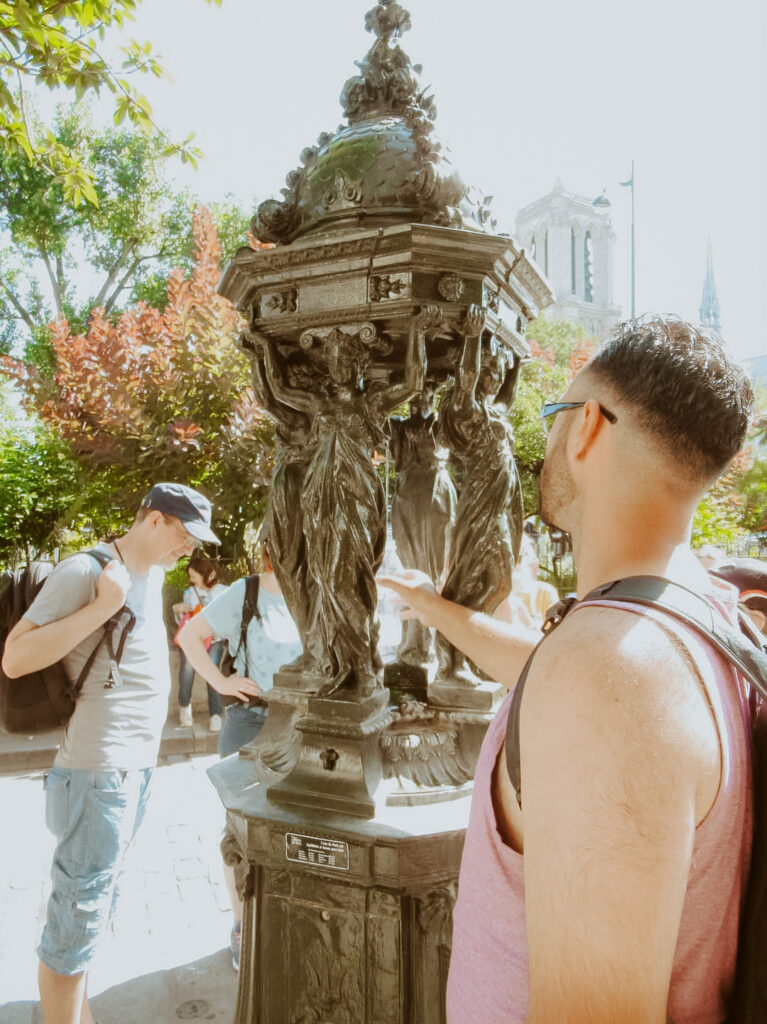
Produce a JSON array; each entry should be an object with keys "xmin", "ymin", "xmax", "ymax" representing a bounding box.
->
[{"xmin": 241, "ymin": 331, "xmax": 322, "ymax": 673}]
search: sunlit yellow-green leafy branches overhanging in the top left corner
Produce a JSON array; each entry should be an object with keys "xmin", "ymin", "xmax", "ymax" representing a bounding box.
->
[{"xmin": 0, "ymin": 0, "xmax": 215, "ymax": 205}]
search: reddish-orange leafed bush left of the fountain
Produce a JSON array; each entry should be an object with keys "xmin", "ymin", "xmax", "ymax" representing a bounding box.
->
[{"xmin": 4, "ymin": 208, "xmax": 273, "ymax": 554}]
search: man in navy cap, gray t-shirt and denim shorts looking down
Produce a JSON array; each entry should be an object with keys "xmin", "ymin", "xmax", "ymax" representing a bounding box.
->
[{"xmin": 3, "ymin": 483, "xmax": 219, "ymax": 1024}]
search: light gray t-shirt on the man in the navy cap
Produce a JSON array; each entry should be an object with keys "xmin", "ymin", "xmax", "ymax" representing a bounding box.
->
[{"xmin": 25, "ymin": 545, "xmax": 170, "ymax": 771}]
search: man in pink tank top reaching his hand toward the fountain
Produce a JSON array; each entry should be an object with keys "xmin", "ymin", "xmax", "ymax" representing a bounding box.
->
[{"xmin": 382, "ymin": 317, "xmax": 753, "ymax": 1024}]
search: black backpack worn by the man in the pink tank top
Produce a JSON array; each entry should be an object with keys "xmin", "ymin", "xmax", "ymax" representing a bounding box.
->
[{"xmin": 506, "ymin": 577, "xmax": 767, "ymax": 1024}]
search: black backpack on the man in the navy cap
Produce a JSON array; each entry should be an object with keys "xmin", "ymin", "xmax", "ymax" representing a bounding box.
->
[{"xmin": 0, "ymin": 550, "xmax": 135, "ymax": 734}]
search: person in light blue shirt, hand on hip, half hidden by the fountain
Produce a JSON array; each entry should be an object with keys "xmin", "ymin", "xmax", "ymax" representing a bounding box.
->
[{"xmin": 178, "ymin": 542, "xmax": 302, "ymax": 970}]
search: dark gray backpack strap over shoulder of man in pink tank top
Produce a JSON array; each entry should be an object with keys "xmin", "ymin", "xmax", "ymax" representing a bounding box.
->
[{"xmin": 506, "ymin": 575, "xmax": 767, "ymax": 807}]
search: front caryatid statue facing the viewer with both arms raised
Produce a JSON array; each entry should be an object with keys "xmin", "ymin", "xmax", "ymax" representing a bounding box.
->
[{"xmin": 256, "ymin": 325, "xmax": 426, "ymax": 697}]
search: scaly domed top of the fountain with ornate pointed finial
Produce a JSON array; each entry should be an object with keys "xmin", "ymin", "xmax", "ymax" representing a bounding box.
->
[{"xmin": 252, "ymin": 0, "xmax": 496, "ymax": 244}]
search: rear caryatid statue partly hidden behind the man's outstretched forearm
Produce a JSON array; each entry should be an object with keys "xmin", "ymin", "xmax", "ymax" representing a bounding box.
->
[{"xmin": 389, "ymin": 382, "xmax": 456, "ymax": 684}]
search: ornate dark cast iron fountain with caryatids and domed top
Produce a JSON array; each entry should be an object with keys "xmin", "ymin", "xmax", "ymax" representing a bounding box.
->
[{"xmin": 206, "ymin": 0, "xmax": 552, "ymax": 1024}]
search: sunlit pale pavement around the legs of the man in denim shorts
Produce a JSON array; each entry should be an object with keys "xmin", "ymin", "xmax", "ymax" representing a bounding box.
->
[{"xmin": 0, "ymin": 755, "xmax": 237, "ymax": 1024}]
